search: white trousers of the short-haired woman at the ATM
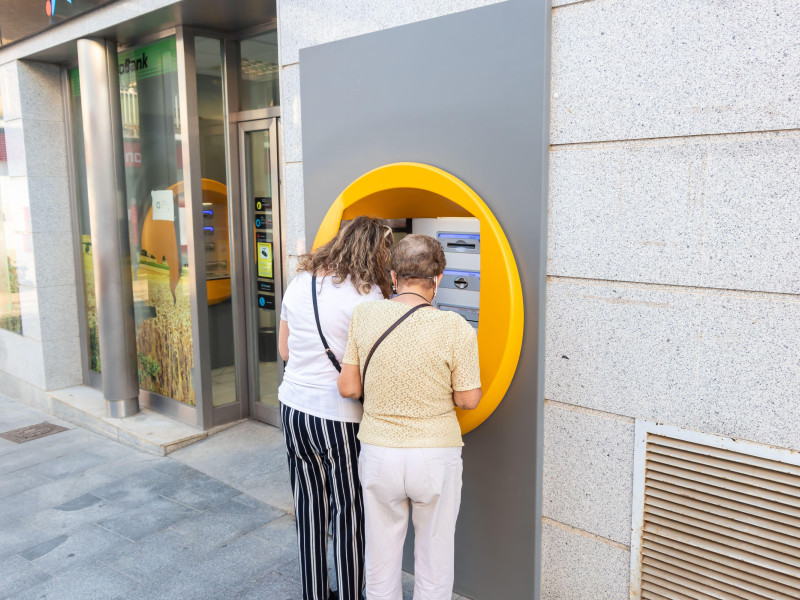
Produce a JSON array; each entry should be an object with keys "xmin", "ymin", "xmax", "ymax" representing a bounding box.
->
[{"xmin": 359, "ymin": 443, "xmax": 462, "ymax": 600}]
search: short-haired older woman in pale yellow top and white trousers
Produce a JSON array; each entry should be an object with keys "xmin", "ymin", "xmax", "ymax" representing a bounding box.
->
[{"xmin": 338, "ymin": 235, "xmax": 481, "ymax": 600}]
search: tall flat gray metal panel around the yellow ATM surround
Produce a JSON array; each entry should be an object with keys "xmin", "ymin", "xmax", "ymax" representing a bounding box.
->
[{"xmin": 300, "ymin": 0, "xmax": 550, "ymax": 600}]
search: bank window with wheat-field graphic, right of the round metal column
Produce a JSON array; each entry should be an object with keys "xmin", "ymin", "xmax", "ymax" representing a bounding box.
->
[{"xmin": 118, "ymin": 37, "xmax": 195, "ymax": 406}]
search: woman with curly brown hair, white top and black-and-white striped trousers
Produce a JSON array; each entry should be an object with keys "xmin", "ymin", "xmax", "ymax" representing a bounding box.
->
[{"xmin": 278, "ymin": 217, "xmax": 392, "ymax": 600}]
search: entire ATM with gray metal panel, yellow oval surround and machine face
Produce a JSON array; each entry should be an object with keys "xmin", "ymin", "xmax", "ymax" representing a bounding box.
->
[{"xmin": 295, "ymin": 0, "xmax": 552, "ymax": 600}]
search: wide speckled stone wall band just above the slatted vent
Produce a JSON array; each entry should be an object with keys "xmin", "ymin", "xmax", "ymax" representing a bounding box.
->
[{"xmin": 545, "ymin": 279, "xmax": 800, "ymax": 449}]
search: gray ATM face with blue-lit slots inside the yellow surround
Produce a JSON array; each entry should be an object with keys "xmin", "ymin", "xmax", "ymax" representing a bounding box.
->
[{"xmin": 411, "ymin": 217, "xmax": 481, "ymax": 330}]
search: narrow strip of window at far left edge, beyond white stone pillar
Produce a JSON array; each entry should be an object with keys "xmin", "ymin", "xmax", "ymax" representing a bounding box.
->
[{"xmin": 0, "ymin": 97, "xmax": 25, "ymax": 333}]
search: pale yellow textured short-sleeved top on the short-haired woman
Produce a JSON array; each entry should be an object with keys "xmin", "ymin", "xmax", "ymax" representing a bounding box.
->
[{"xmin": 342, "ymin": 300, "xmax": 481, "ymax": 448}]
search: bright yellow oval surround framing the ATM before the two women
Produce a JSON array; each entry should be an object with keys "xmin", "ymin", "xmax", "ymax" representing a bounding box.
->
[{"xmin": 314, "ymin": 163, "xmax": 525, "ymax": 433}]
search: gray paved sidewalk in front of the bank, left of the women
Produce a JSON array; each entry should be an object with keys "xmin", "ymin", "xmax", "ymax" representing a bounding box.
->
[{"xmin": 0, "ymin": 395, "xmax": 468, "ymax": 600}]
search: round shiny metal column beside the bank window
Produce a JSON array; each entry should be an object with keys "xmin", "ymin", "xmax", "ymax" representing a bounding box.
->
[{"xmin": 78, "ymin": 40, "xmax": 139, "ymax": 417}]
